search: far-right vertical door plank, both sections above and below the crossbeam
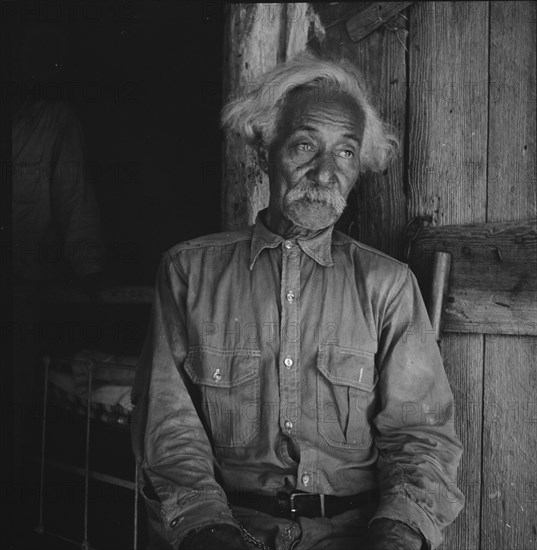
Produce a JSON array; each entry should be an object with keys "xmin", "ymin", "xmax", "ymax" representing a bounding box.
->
[{"xmin": 482, "ymin": 2, "xmax": 537, "ymax": 550}]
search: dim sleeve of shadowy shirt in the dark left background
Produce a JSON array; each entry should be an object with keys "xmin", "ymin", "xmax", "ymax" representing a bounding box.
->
[{"xmin": 51, "ymin": 103, "xmax": 104, "ymax": 277}]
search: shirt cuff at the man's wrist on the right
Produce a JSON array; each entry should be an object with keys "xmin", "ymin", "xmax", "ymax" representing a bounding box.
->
[{"xmin": 369, "ymin": 493, "xmax": 444, "ymax": 550}]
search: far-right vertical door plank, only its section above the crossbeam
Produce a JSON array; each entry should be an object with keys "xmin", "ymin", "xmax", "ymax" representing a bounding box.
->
[{"xmin": 487, "ymin": 2, "xmax": 537, "ymax": 221}]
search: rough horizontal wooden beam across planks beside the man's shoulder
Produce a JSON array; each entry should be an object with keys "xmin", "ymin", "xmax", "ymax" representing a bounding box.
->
[{"xmin": 409, "ymin": 220, "xmax": 537, "ymax": 335}]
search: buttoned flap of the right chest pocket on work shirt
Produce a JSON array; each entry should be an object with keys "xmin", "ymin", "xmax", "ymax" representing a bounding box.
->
[{"xmin": 317, "ymin": 345, "xmax": 377, "ymax": 391}]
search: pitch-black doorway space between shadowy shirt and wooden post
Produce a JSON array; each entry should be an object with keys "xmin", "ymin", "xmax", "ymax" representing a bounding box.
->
[{"xmin": 13, "ymin": 0, "xmax": 224, "ymax": 285}]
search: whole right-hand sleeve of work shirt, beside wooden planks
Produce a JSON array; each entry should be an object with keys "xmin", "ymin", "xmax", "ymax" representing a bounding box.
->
[{"xmin": 371, "ymin": 267, "xmax": 464, "ymax": 548}]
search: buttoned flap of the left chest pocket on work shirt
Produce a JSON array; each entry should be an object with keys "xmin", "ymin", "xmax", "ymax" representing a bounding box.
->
[{"xmin": 185, "ymin": 346, "xmax": 261, "ymax": 388}]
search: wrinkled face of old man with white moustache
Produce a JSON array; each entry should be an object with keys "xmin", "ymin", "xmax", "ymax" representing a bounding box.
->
[{"xmin": 268, "ymin": 85, "xmax": 364, "ymax": 230}]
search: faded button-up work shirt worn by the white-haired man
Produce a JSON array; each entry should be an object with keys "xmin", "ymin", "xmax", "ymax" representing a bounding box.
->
[{"xmin": 132, "ymin": 209, "xmax": 463, "ymax": 548}]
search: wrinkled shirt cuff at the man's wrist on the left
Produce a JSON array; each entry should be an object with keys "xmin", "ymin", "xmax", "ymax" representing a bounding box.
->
[{"xmin": 141, "ymin": 491, "xmax": 239, "ymax": 550}]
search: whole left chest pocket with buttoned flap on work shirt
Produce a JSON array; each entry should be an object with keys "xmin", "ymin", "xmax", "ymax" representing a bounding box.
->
[{"xmin": 185, "ymin": 346, "xmax": 261, "ymax": 447}]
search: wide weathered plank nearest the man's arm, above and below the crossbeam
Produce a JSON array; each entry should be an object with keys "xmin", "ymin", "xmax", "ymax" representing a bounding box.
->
[{"xmin": 406, "ymin": 2, "xmax": 489, "ymax": 550}]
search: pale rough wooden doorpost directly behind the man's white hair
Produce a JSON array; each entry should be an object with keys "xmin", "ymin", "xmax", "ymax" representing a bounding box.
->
[{"xmin": 222, "ymin": 2, "xmax": 323, "ymax": 230}]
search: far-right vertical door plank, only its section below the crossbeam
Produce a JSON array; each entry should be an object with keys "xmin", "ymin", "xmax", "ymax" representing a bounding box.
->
[{"xmin": 481, "ymin": 336, "xmax": 537, "ymax": 550}]
